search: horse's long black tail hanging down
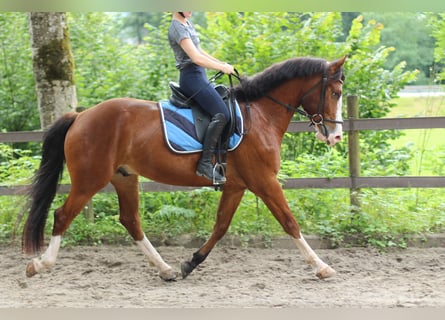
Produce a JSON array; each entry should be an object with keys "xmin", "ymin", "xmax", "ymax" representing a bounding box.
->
[{"xmin": 22, "ymin": 112, "xmax": 77, "ymax": 253}]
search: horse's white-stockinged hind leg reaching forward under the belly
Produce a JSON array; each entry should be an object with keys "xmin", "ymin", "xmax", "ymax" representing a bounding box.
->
[{"xmin": 111, "ymin": 173, "xmax": 177, "ymax": 281}]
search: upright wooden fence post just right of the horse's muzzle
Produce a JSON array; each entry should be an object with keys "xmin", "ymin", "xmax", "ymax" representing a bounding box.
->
[{"xmin": 346, "ymin": 95, "xmax": 360, "ymax": 214}]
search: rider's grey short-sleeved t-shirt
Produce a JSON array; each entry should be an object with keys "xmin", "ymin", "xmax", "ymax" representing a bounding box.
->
[{"xmin": 168, "ymin": 19, "xmax": 200, "ymax": 69}]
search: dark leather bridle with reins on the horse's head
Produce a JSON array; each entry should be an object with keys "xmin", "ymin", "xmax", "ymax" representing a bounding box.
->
[{"xmin": 266, "ymin": 67, "xmax": 343, "ymax": 138}]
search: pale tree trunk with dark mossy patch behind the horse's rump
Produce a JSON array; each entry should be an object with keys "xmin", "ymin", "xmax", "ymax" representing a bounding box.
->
[{"xmin": 29, "ymin": 12, "xmax": 77, "ymax": 129}]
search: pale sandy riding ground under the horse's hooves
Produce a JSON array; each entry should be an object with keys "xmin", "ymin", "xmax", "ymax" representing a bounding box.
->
[{"xmin": 0, "ymin": 246, "xmax": 445, "ymax": 308}]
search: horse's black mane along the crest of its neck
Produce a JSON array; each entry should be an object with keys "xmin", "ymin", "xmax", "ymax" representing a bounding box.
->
[{"xmin": 234, "ymin": 58, "xmax": 327, "ymax": 101}]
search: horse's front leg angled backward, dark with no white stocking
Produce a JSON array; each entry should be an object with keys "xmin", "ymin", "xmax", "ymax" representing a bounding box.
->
[{"xmin": 181, "ymin": 185, "xmax": 245, "ymax": 278}]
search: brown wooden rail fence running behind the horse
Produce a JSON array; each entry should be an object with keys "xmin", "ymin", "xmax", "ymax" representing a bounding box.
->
[{"xmin": 0, "ymin": 96, "xmax": 445, "ymax": 199}]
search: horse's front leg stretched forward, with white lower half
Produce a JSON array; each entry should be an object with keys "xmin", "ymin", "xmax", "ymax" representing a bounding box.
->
[{"xmin": 254, "ymin": 179, "xmax": 336, "ymax": 279}]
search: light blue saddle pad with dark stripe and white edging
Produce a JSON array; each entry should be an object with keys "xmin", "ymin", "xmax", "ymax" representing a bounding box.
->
[{"xmin": 159, "ymin": 100, "xmax": 243, "ymax": 153}]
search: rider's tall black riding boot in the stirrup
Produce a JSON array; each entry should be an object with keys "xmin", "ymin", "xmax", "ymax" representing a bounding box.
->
[{"xmin": 196, "ymin": 113, "xmax": 227, "ymax": 184}]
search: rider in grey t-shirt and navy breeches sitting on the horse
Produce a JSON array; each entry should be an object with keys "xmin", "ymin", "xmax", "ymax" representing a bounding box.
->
[{"xmin": 168, "ymin": 11, "xmax": 234, "ymax": 184}]
